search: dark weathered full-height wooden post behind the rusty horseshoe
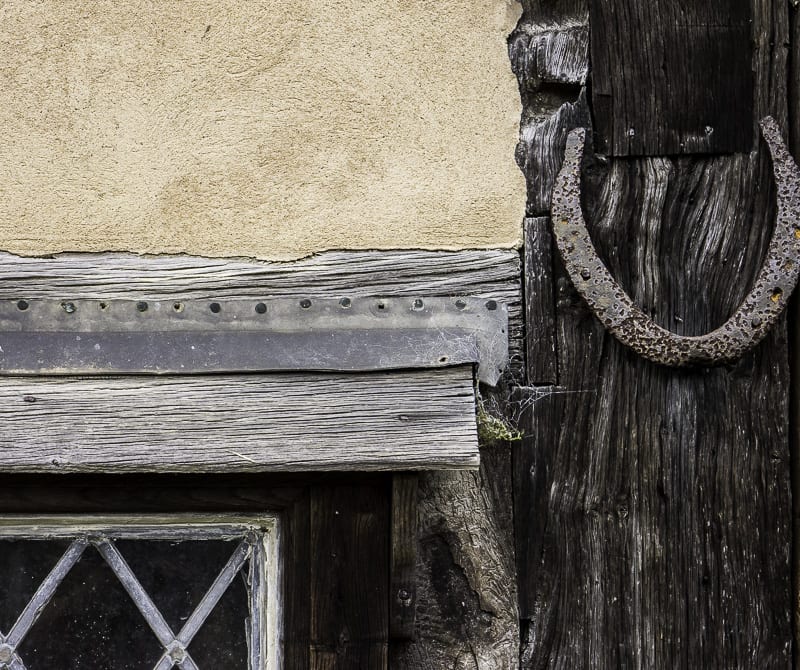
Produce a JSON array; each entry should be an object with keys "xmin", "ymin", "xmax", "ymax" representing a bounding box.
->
[{"xmin": 510, "ymin": 0, "xmax": 794, "ymax": 668}]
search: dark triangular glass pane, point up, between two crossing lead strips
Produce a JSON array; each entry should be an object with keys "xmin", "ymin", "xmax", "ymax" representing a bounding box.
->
[{"xmin": 19, "ymin": 542, "xmax": 163, "ymax": 670}]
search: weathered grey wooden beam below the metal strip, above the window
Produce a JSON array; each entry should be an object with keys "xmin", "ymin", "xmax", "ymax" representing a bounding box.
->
[{"xmin": 0, "ymin": 366, "xmax": 478, "ymax": 472}]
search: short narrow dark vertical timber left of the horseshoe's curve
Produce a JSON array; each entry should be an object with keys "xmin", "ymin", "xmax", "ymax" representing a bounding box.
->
[{"xmin": 524, "ymin": 217, "xmax": 558, "ymax": 385}]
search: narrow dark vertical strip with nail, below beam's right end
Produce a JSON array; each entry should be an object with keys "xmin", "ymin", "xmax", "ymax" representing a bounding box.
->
[{"xmin": 389, "ymin": 473, "xmax": 419, "ymax": 640}]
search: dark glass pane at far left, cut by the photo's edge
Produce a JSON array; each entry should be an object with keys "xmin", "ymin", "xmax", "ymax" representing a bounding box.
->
[{"xmin": 0, "ymin": 540, "xmax": 70, "ymax": 633}]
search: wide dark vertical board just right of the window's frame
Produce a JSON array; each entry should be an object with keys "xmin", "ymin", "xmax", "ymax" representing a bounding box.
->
[{"xmin": 310, "ymin": 482, "xmax": 390, "ymax": 670}]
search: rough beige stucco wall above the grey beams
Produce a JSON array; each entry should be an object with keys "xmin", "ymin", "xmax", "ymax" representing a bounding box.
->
[{"xmin": 0, "ymin": 0, "xmax": 525, "ymax": 259}]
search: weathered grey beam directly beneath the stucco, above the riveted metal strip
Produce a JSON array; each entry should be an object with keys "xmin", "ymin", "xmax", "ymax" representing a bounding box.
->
[{"xmin": 0, "ymin": 250, "xmax": 524, "ymax": 375}]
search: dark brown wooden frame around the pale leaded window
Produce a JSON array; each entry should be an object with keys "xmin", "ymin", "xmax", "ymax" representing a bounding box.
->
[{"xmin": 0, "ymin": 473, "xmax": 396, "ymax": 670}]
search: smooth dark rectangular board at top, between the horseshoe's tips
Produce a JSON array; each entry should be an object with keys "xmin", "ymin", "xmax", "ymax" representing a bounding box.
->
[{"xmin": 590, "ymin": 0, "xmax": 755, "ymax": 156}]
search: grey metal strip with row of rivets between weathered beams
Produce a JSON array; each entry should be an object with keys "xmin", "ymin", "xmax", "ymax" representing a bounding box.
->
[{"xmin": 0, "ymin": 297, "xmax": 508, "ymax": 385}]
